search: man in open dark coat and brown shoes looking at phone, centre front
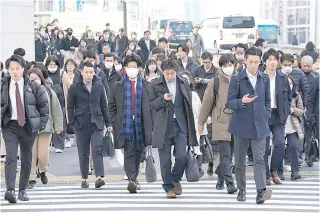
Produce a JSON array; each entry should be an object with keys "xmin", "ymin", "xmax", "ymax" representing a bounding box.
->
[{"xmin": 150, "ymin": 59, "xmax": 198, "ymax": 198}]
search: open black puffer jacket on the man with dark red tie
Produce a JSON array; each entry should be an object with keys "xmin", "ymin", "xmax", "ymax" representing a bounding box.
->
[{"xmin": 1, "ymin": 76, "xmax": 49, "ymax": 132}]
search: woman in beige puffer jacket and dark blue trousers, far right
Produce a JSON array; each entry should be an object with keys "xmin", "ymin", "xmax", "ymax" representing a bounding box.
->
[{"xmin": 285, "ymin": 76, "xmax": 304, "ymax": 180}]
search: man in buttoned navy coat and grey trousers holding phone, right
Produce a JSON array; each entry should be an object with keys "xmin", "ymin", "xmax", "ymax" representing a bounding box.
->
[{"xmin": 226, "ymin": 47, "xmax": 272, "ymax": 204}]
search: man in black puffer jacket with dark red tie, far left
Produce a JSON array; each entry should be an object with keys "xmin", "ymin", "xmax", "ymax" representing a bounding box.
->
[{"xmin": 1, "ymin": 55, "xmax": 49, "ymax": 203}]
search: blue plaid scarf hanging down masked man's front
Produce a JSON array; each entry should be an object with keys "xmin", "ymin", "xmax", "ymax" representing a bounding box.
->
[{"xmin": 121, "ymin": 75, "xmax": 144, "ymax": 150}]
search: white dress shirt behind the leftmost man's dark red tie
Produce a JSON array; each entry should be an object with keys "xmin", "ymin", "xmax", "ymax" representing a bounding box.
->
[{"xmin": 9, "ymin": 78, "xmax": 24, "ymax": 120}]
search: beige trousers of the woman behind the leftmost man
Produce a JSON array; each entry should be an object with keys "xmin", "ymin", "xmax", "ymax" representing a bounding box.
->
[{"xmin": 29, "ymin": 132, "xmax": 52, "ymax": 180}]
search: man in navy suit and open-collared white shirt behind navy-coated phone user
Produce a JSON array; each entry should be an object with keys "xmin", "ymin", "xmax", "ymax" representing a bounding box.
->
[{"xmin": 262, "ymin": 49, "xmax": 292, "ymax": 185}]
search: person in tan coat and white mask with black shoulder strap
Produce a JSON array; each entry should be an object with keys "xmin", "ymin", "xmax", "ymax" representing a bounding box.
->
[{"xmin": 197, "ymin": 54, "xmax": 238, "ymax": 194}]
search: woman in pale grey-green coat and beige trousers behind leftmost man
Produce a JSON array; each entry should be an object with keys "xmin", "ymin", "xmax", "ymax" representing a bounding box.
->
[{"xmin": 28, "ymin": 68, "xmax": 63, "ymax": 189}]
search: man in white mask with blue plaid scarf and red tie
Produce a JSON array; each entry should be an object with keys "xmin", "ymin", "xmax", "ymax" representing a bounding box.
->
[{"xmin": 109, "ymin": 55, "xmax": 152, "ymax": 193}]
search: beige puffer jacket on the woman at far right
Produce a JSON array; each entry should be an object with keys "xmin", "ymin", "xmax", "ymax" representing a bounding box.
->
[{"xmin": 284, "ymin": 93, "xmax": 304, "ymax": 140}]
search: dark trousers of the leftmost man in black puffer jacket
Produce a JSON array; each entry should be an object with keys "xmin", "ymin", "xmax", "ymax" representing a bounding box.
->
[{"xmin": 2, "ymin": 121, "xmax": 36, "ymax": 190}]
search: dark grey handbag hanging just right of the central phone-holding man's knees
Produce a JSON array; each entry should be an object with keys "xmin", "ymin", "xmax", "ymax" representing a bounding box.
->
[{"xmin": 185, "ymin": 147, "xmax": 200, "ymax": 182}]
